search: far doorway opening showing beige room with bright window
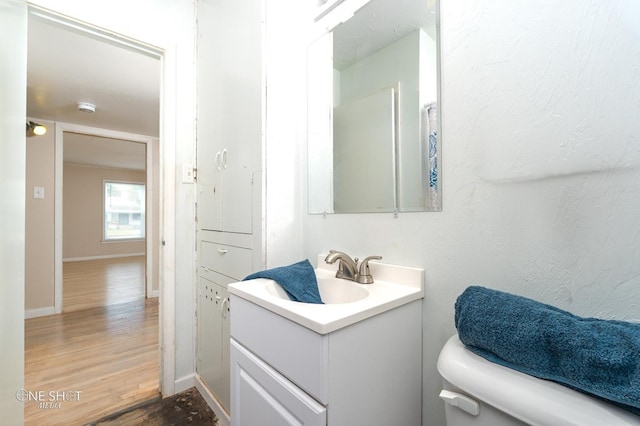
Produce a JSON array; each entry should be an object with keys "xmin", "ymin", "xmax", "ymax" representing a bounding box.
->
[{"xmin": 56, "ymin": 129, "xmax": 150, "ymax": 312}]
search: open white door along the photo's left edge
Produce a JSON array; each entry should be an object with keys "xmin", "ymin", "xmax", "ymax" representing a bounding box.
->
[{"xmin": 0, "ymin": 0, "xmax": 27, "ymax": 425}]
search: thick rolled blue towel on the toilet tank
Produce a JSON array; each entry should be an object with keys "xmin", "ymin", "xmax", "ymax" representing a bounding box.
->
[{"xmin": 455, "ymin": 286, "xmax": 640, "ymax": 415}]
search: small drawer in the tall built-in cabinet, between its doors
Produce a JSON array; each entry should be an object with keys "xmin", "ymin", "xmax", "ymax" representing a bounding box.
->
[{"xmin": 200, "ymin": 241, "xmax": 253, "ymax": 280}]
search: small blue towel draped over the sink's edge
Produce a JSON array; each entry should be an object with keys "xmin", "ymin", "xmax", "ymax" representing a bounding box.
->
[{"xmin": 242, "ymin": 259, "xmax": 323, "ymax": 303}]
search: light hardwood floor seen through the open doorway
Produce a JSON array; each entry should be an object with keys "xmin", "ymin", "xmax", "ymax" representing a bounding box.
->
[{"xmin": 26, "ymin": 257, "xmax": 159, "ymax": 426}]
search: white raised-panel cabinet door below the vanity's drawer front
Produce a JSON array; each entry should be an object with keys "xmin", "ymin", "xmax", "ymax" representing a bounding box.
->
[{"xmin": 231, "ymin": 340, "xmax": 327, "ymax": 426}]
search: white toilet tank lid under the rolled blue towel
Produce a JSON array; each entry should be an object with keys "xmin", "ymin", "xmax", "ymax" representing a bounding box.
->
[{"xmin": 437, "ymin": 335, "xmax": 640, "ymax": 426}]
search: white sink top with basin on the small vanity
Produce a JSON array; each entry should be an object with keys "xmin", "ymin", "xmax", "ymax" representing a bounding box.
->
[{"xmin": 228, "ymin": 255, "xmax": 424, "ymax": 334}]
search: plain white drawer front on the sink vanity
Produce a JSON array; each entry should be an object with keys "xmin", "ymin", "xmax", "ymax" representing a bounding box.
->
[{"xmin": 231, "ymin": 294, "xmax": 329, "ymax": 404}]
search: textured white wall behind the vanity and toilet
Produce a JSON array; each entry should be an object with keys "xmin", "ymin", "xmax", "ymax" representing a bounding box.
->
[{"xmin": 298, "ymin": 0, "xmax": 640, "ymax": 425}]
